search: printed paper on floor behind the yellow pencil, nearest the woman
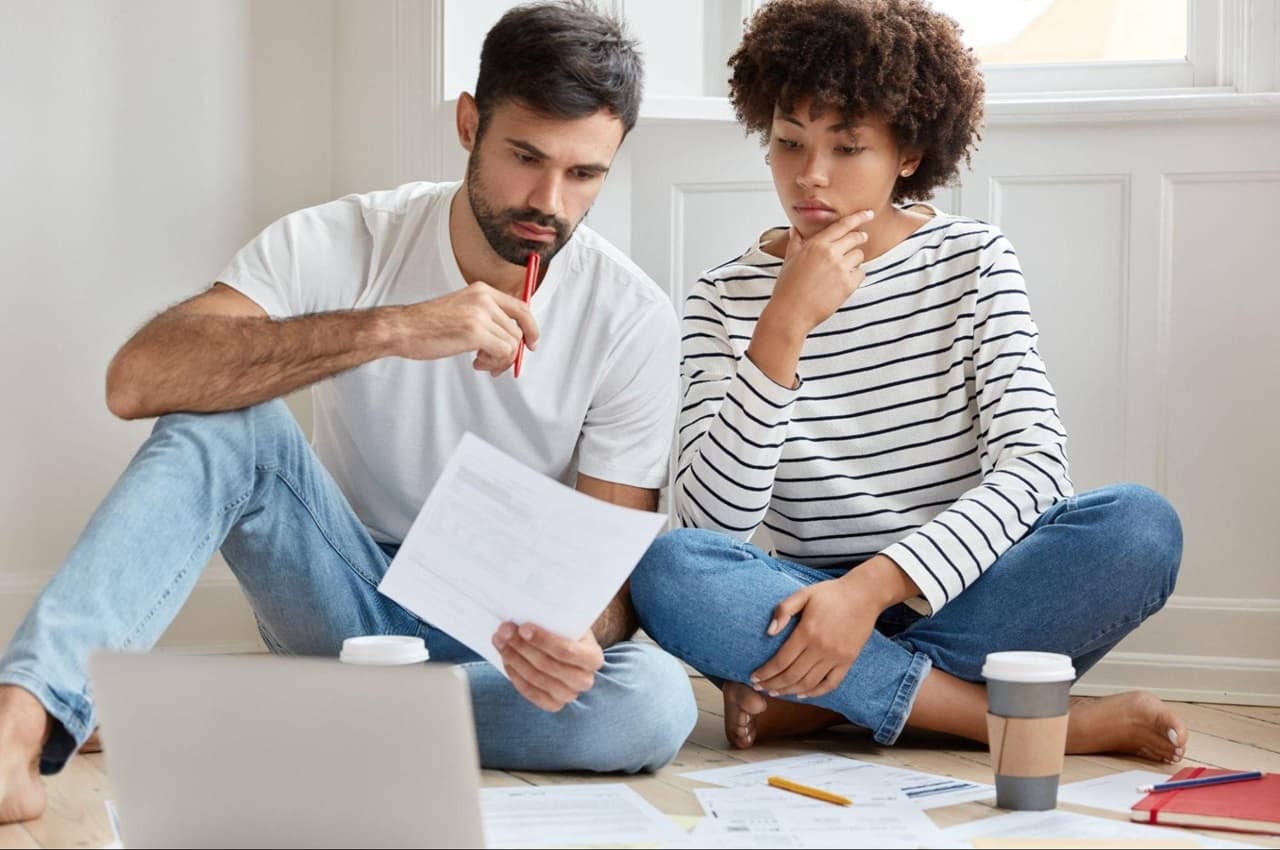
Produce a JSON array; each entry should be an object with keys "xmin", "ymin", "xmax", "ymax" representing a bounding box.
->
[{"xmin": 684, "ymin": 753, "xmax": 996, "ymax": 809}]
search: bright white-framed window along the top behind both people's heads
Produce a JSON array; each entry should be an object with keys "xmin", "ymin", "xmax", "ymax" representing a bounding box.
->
[{"xmin": 442, "ymin": 0, "xmax": 1280, "ymax": 122}]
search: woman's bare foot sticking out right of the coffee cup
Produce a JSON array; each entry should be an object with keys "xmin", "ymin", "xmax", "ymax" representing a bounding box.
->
[{"xmin": 1066, "ymin": 691, "xmax": 1188, "ymax": 764}]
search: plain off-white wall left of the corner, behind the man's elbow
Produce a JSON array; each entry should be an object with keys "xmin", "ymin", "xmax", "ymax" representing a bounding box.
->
[{"xmin": 0, "ymin": 0, "xmax": 333, "ymax": 646}]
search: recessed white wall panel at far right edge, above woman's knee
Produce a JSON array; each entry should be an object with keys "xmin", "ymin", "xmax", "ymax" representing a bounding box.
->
[{"xmin": 1161, "ymin": 172, "xmax": 1280, "ymax": 596}]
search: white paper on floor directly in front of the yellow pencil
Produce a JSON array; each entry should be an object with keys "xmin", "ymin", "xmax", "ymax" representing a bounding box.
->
[{"xmin": 694, "ymin": 786, "xmax": 945, "ymax": 847}]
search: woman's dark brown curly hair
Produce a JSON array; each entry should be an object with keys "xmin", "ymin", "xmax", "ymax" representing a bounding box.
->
[{"xmin": 728, "ymin": 0, "xmax": 983, "ymax": 201}]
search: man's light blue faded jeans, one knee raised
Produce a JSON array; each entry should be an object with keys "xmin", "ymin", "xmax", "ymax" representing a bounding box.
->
[{"xmin": 0, "ymin": 401, "xmax": 698, "ymax": 773}]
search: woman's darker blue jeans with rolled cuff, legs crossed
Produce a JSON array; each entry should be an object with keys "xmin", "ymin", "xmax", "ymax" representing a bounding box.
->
[{"xmin": 631, "ymin": 485, "xmax": 1183, "ymax": 744}]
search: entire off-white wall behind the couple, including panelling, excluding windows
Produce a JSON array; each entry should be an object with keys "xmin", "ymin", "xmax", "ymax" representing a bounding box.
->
[{"xmin": 0, "ymin": 0, "xmax": 1280, "ymax": 703}]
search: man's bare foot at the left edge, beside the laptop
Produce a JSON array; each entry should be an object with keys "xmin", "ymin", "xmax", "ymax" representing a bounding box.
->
[{"xmin": 0, "ymin": 685, "xmax": 51, "ymax": 823}]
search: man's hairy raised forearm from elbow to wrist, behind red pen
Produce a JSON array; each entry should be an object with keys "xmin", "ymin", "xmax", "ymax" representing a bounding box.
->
[{"xmin": 108, "ymin": 307, "xmax": 394, "ymax": 419}]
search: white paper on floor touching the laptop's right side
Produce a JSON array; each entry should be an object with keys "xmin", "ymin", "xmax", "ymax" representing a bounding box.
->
[{"xmin": 480, "ymin": 782, "xmax": 685, "ymax": 847}]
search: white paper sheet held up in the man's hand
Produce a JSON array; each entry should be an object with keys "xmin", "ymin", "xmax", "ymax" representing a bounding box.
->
[{"xmin": 378, "ymin": 434, "xmax": 667, "ymax": 672}]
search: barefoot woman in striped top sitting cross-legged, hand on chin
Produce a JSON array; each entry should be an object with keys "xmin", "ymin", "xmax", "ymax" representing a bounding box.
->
[{"xmin": 631, "ymin": 0, "xmax": 1187, "ymax": 762}]
